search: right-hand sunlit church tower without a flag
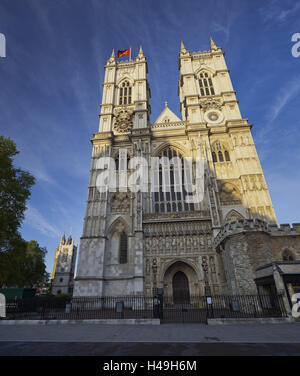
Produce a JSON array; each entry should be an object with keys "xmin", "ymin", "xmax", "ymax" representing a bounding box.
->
[{"xmin": 179, "ymin": 38, "xmax": 276, "ymax": 226}]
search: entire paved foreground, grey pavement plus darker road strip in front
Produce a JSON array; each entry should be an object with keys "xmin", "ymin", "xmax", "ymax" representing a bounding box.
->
[{"xmin": 0, "ymin": 323, "xmax": 300, "ymax": 357}]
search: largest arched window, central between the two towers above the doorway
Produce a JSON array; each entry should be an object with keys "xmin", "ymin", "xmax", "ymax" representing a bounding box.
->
[{"xmin": 153, "ymin": 148, "xmax": 195, "ymax": 213}]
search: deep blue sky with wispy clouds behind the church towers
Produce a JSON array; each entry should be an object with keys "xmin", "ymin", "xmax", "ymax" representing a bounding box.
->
[{"xmin": 0, "ymin": 0, "xmax": 300, "ymax": 271}]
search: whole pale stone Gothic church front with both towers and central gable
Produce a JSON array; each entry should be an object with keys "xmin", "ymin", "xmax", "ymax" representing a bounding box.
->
[{"xmin": 74, "ymin": 38, "xmax": 284, "ymax": 302}]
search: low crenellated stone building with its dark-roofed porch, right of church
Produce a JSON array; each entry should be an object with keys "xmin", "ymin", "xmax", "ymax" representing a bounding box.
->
[{"xmin": 214, "ymin": 219, "xmax": 300, "ymax": 311}]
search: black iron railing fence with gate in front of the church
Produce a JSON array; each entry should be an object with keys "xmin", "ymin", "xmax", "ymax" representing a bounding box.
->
[{"xmin": 4, "ymin": 295, "xmax": 286, "ymax": 323}]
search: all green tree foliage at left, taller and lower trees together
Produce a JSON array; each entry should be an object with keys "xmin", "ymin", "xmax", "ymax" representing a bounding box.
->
[{"xmin": 0, "ymin": 136, "xmax": 49, "ymax": 287}]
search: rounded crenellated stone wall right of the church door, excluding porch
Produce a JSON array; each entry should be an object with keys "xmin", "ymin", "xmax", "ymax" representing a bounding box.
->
[{"xmin": 214, "ymin": 220, "xmax": 300, "ymax": 294}]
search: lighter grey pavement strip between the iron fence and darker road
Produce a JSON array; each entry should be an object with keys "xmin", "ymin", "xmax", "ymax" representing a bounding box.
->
[{"xmin": 0, "ymin": 323, "xmax": 300, "ymax": 343}]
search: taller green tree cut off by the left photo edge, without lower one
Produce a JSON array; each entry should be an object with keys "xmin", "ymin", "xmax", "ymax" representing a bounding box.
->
[{"xmin": 0, "ymin": 136, "xmax": 34, "ymax": 251}]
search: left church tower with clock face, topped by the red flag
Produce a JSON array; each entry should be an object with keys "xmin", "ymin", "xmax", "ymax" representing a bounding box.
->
[{"xmin": 74, "ymin": 47, "xmax": 151, "ymax": 296}]
